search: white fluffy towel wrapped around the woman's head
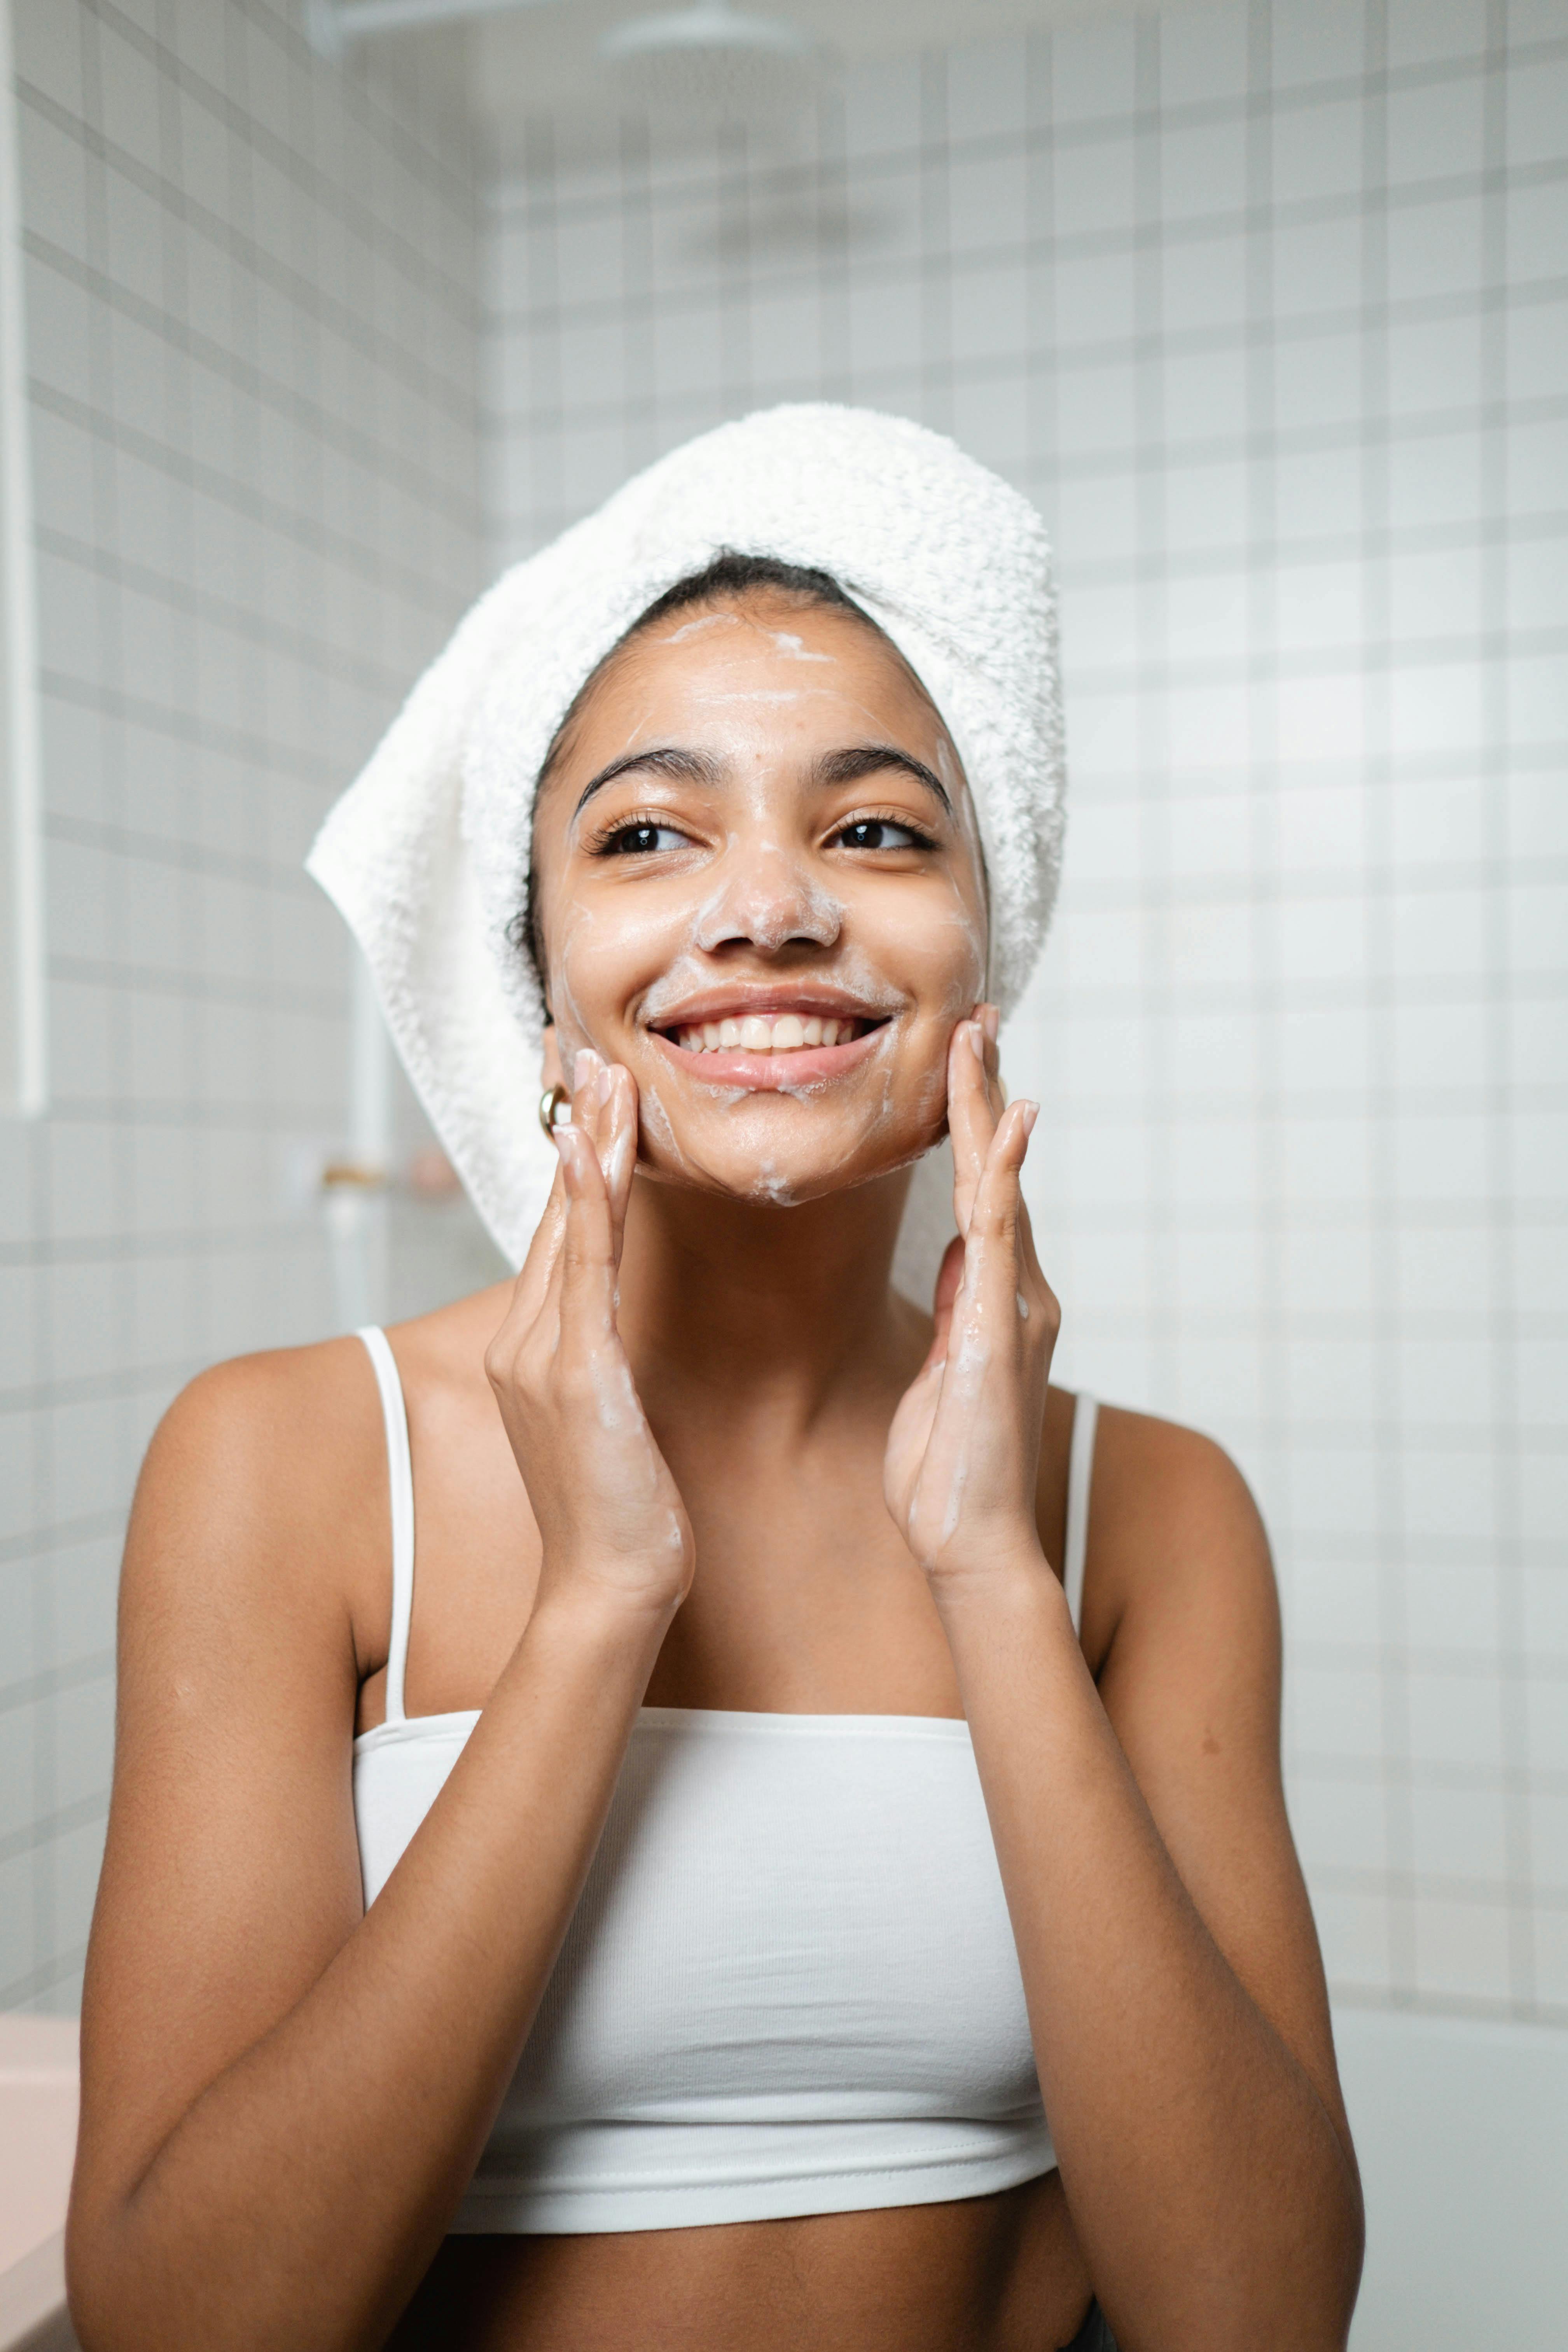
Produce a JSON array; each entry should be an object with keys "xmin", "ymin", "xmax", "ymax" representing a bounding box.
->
[{"xmin": 308, "ymin": 404, "xmax": 1063, "ymax": 1298}]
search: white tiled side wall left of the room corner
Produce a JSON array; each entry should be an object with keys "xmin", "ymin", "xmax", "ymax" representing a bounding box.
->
[{"xmin": 0, "ymin": 0, "xmax": 482, "ymax": 2009}]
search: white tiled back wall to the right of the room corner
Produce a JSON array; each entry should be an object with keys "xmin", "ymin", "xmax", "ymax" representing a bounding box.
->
[{"xmin": 489, "ymin": 0, "xmax": 1568, "ymax": 2018}]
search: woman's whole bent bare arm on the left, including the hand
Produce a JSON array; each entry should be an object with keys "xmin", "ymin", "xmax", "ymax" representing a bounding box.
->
[{"xmin": 68, "ymin": 1072, "xmax": 691, "ymax": 2352}]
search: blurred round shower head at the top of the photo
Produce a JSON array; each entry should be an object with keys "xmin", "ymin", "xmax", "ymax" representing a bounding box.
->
[{"xmin": 600, "ymin": 0, "xmax": 823, "ymax": 120}]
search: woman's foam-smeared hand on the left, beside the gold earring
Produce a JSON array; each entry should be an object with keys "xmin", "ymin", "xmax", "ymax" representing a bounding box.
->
[{"xmin": 484, "ymin": 1051, "xmax": 696, "ymax": 1614}]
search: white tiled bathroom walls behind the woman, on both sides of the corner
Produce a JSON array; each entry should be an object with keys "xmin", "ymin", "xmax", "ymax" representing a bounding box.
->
[{"xmin": 0, "ymin": 0, "xmax": 1568, "ymax": 2079}]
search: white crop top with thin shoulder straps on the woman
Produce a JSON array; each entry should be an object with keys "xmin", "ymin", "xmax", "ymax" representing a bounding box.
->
[{"xmin": 353, "ymin": 1331, "xmax": 1096, "ymax": 2235}]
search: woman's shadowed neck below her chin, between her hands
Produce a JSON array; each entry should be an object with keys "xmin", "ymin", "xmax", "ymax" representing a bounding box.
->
[{"xmin": 621, "ymin": 1169, "xmax": 919, "ymax": 1437}]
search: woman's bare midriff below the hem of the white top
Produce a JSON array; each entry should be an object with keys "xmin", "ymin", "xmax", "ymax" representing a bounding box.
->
[{"xmin": 388, "ymin": 2173, "xmax": 1091, "ymax": 2352}]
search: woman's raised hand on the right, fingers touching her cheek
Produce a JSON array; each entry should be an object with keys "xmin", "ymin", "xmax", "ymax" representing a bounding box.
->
[{"xmin": 881, "ymin": 1004, "xmax": 1060, "ymax": 1588}]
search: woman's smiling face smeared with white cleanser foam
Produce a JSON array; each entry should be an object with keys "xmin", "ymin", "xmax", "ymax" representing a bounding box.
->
[{"xmin": 534, "ymin": 593, "xmax": 985, "ymax": 1202}]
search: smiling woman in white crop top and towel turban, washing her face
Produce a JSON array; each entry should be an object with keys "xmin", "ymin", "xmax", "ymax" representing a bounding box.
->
[{"xmin": 70, "ymin": 412, "xmax": 1361, "ymax": 2352}]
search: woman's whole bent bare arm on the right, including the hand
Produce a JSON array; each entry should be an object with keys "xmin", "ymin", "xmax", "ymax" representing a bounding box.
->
[{"xmin": 886, "ymin": 1023, "xmax": 1361, "ymax": 2352}]
